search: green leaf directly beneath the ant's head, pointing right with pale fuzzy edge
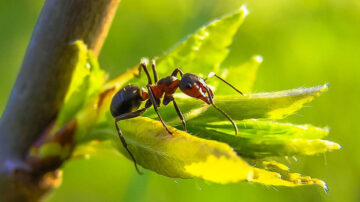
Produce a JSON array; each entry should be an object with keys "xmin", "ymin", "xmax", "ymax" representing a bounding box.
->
[{"xmin": 143, "ymin": 85, "xmax": 328, "ymax": 126}]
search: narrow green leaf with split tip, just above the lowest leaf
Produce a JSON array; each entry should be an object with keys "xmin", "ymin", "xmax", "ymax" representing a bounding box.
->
[{"xmin": 188, "ymin": 119, "xmax": 340, "ymax": 158}]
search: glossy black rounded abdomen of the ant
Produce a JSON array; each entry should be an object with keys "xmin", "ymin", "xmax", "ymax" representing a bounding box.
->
[{"xmin": 110, "ymin": 84, "xmax": 143, "ymax": 117}]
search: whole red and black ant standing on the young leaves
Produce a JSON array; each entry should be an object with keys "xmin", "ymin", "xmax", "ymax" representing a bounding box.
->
[{"xmin": 110, "ymin": 60, "xmax": 243, "ymax": 174}]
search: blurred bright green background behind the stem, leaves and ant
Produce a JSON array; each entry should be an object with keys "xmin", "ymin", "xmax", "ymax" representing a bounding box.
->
[{"xmin": 0, "ymin": 0, "xmax": 360, "ymax": 202}]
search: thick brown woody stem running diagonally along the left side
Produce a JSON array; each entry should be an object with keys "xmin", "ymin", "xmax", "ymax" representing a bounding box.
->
[{"xmin": 0, "ymin": 0, "xmax": 120, "ymax": 201}]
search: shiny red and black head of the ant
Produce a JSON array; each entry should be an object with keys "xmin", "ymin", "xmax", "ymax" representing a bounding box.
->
[{"xmin": 179, "ymin": 73, "xmax": 214, "ymax": 104}]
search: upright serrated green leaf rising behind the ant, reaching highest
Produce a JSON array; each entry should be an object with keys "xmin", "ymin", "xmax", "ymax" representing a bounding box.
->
[{"xmin": 157, "ymin": 6, "xmax": 248, "ymax": 76}]
